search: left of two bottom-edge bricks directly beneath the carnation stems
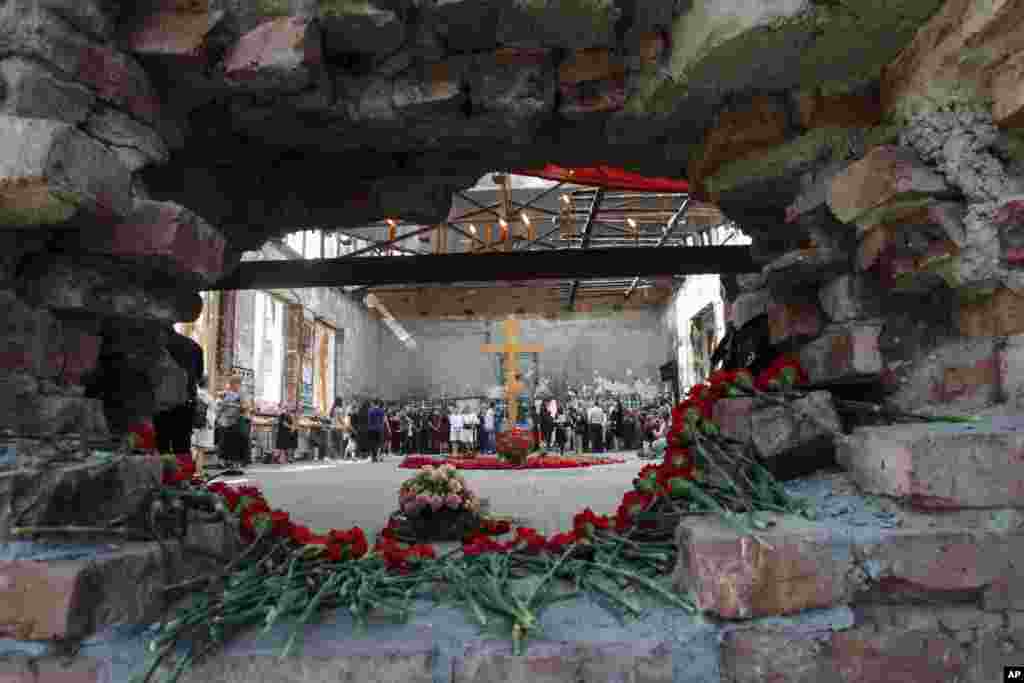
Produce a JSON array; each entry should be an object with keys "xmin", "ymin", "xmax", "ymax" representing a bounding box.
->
[{"xmin": 181, "ymin": 628, "xmax": 434, "ymax": 683}]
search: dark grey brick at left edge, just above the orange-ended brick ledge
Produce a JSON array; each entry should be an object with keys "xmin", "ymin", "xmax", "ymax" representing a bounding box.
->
[{"xmin": 0, "ymin": 456, "xmax": 162, "ymax": 538}]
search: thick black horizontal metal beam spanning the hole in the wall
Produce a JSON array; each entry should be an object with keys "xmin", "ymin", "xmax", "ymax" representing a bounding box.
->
[{"xmin": 209, "ymin": 246, "xmax": 761, "ymax": 290}]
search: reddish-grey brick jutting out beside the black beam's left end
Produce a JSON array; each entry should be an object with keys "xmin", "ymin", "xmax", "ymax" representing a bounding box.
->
[{"xmin": 80, "ymin": 201, "xmax": 227, "ymax": 285}]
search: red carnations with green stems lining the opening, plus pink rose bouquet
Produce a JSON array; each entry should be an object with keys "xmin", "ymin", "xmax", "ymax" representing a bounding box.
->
[{"xmin": 142, "ymin": 358, "xmax": 827, "ymax": 680}]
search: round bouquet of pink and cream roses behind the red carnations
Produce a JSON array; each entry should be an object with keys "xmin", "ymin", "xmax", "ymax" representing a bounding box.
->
[{"xmin": 398, "ymin": 463, "xmax": 480, "ymax": 541}]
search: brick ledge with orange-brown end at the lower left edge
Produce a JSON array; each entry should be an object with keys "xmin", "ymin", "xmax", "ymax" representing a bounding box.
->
[{"xmin": 0, "ymin": 524, "xmax": 238, "ymax": 640}]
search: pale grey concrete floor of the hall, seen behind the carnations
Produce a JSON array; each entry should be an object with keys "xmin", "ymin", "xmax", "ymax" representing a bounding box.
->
[{"xmin": 219, "ymin": 453, "xmax": 644, "ymax": 539}]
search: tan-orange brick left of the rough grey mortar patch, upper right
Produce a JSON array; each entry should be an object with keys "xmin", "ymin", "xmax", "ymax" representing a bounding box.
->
[{"xmin": 828, "ymin": 146, "xmax": 948, "ymax": 223}]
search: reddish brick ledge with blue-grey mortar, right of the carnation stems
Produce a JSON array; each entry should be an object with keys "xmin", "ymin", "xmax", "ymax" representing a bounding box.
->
[{"xmin": 674, "ymin": 475, "xmax": 1024, "ymax": 618}]
